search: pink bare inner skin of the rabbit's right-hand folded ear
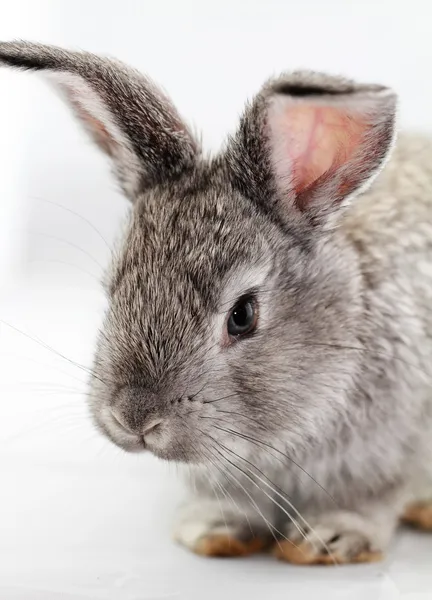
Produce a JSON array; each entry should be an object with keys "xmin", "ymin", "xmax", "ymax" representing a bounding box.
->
[{"xmin": 269, "ymin": 101, "xmax": 368, "ymax": 196}]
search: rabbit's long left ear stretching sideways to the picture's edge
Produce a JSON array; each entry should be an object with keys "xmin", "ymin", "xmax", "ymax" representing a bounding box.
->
[{"xmin": 0, "ymin": 42, "xmax": 199, "ymax": 199}]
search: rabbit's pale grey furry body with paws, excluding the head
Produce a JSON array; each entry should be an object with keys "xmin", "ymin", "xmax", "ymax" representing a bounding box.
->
[{"xmin": 176, "ymin": 134, "xmax": 432, "ymax": 562}]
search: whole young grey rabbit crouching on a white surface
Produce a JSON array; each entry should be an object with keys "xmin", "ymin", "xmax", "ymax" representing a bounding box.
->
[{"xmin": 0, "ymin": 42, "xmax": 432, "ymax": 565}]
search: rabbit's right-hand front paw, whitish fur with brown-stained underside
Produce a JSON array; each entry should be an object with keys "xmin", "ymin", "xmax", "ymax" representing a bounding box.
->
[{"xmin": 274, "ymin": 512, "xmax": 383, "ymax": 565}]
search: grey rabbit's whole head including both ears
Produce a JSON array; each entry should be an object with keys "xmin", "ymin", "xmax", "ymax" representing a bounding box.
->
[{"xmin": 0, "ymin": 43, "xmax": 395, "ymax": 463}]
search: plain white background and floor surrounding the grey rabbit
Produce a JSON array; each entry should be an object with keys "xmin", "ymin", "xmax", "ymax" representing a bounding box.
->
[{"xmin": 0, "ymin": 0, "xmax": 432, "ymax": 600}]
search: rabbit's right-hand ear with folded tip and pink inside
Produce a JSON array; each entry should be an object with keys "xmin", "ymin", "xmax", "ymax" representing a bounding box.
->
[{"xmin": 227, "ymin": 72, "xmax": 396, "ymax": 227}]
